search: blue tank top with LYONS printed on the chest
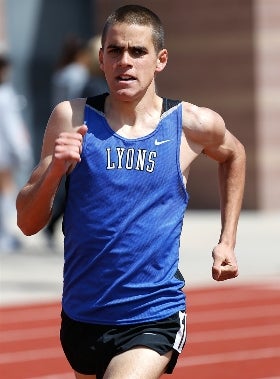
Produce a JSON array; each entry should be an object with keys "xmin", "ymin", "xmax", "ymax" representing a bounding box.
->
[{"xmin": 62, "ymin": 94, "xmax": 188, "ymax": 325}]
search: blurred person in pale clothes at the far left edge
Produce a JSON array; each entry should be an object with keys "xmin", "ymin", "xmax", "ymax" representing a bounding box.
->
[{"xmin": 0, "ymin": 53, "xmax": 33, "ymax": 253}]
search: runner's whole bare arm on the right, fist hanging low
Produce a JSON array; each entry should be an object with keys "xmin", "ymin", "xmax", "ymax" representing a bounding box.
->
[{"xmin": 184, "ymin": 108, "xmax": 246, "ymax": 281}]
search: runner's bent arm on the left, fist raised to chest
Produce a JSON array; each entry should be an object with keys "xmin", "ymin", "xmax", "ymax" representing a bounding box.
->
[{"xmin": 16, "ymin": 100, "xmax": 87, "ymax": 235}]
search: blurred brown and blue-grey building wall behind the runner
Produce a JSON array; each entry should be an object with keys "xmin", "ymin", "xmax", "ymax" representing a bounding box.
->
[{"xmin": 0, "ymin": 0, "xmax": 280, "ymax": 211}]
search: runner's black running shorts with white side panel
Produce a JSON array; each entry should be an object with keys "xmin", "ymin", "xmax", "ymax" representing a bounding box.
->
[{"xmin": 60, "ymin": 311, "xmax": 186, "ymax": 379}]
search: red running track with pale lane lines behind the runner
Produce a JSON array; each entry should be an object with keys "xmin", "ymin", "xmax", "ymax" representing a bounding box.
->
[{"xmin": 0, "ymin": 284, "xmax": 280, "ymax": 379}]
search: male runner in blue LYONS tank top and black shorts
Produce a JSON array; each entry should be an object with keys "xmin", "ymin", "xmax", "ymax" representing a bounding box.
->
[{"xmin": 17, "ymin": 5, "xmax": 245, "ymax": 379}]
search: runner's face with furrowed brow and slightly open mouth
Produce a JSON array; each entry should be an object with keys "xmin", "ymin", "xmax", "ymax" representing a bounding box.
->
[{"xmin": 100, "ymin": 23, "xmax": 167, "ymax": 100}]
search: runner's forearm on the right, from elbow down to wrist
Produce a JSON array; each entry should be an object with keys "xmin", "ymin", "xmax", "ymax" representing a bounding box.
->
[{"xmin": 219, "ymin": 142, "xmax": 246, "ymax": 248}]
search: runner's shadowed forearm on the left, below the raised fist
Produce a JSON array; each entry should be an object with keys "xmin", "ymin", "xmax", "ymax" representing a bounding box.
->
[{"xmin": 16, "ymin": 168, "xmax": 61, "ymax": 235}]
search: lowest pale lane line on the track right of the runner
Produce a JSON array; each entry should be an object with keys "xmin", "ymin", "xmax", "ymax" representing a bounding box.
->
[{"xmin": 177, "ymin": 347, "xmax": 280, "ymax": 367}]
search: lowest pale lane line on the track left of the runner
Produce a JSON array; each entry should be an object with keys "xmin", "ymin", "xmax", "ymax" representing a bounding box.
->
[{"xmin": 0, "ymin": 347, "xmax": 64, "ymax": 364}]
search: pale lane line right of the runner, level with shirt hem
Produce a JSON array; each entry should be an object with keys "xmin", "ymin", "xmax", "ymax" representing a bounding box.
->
[{"xmin": 188, "ymin": 305, "xmax": 280, "ymax": 324}]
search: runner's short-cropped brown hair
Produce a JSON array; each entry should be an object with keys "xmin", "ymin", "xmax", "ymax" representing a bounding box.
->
[{"xmin": 102, "ymin": 5, "xmax": 164, "ymax": 52}]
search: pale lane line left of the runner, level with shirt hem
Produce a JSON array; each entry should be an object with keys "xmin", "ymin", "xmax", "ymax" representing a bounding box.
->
[{"xmin": 0, "ymin": 306, "xmax": 60, "ymax": 325}]
